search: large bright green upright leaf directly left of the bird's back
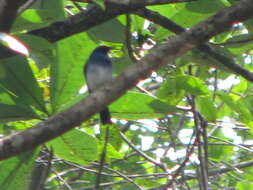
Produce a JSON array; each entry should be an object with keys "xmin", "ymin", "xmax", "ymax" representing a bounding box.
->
[{"xmin": 50, "ymin": 33, "xmax": 95, "ymax": 112}]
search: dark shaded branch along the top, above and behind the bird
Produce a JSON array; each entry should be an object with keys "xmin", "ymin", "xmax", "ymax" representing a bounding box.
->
[{"xmin": 28, "ymin": 0, "xmax": 188, "ymax": 42}]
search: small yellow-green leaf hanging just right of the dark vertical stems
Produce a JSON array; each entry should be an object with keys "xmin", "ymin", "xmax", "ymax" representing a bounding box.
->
[{"xmin": 196, "ymin": 96, "xmax": 218, "ymax": 121}]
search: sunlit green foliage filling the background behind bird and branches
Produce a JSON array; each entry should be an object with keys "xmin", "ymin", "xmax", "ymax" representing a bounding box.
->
[{"xmin": 0, "ymin": 0, "xmax": 253, "ymax": 190}]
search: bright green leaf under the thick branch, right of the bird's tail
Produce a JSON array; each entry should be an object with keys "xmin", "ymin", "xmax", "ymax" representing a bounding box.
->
[{"xmin": 110, "ymin": 92, "xmax": 175, "ymax": 120}]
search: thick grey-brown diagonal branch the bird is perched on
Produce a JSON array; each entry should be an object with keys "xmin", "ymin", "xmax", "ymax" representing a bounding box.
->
[{"xmin": 0, "ymin": 0, "xmax": 253, "ymax": 160}]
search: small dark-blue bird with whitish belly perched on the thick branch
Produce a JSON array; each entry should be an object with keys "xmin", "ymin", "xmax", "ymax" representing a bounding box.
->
[{"xmin": 84, "ymin": 45, "xmax": 112, "ymax": 124}]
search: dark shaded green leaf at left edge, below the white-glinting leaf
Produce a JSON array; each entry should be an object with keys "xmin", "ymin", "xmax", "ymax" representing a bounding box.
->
[{"xmin": 0, "ymin": 56, "xmax": 47, "ymax": 113}]
